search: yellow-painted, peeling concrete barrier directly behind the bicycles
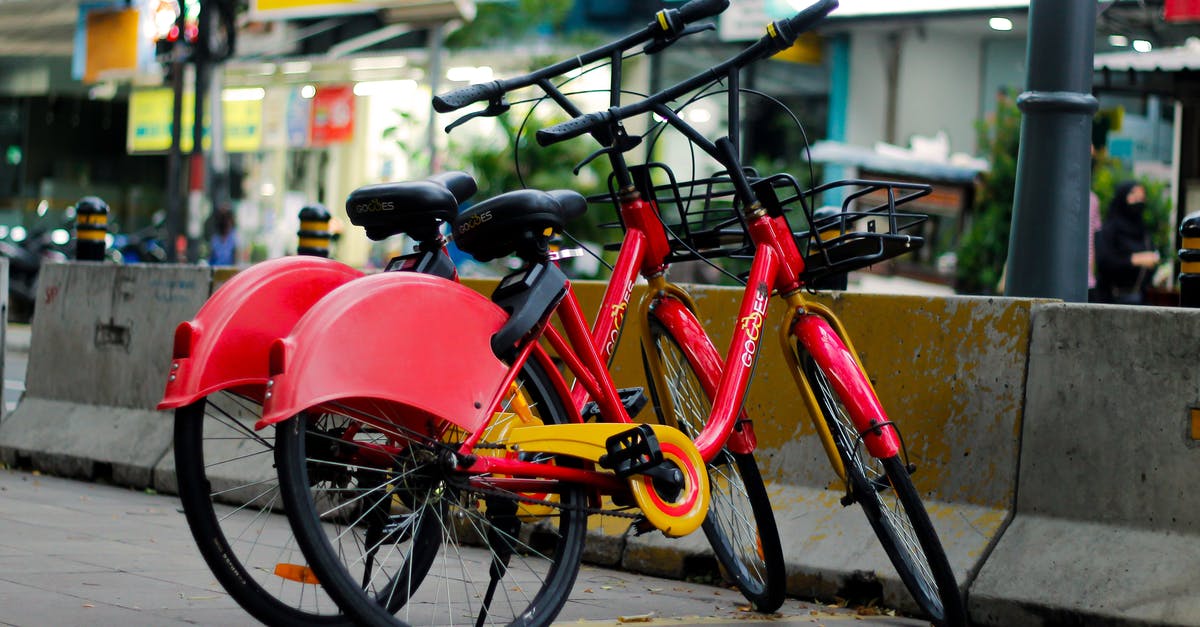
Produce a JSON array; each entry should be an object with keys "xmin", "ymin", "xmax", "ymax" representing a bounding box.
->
[{"xmin": 472, "ymin": 282, "xmax": 1036, "ymax": 609}]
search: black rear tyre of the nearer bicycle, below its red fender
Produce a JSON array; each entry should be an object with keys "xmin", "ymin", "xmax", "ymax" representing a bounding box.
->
[{"xmin": 276, "ymin": 355, "xmax": 587, "ymax": 627}]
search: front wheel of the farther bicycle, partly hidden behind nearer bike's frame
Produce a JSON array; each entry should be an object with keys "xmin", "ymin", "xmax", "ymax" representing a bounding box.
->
[{"xmin": 643, "ymin": 316, "xmax": 787, "ymax": 613}]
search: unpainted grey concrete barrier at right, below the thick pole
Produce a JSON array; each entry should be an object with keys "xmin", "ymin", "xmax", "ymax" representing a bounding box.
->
[{"xmin": 970, "ymin": 305, "xmax": 1200, "ymax": 626}]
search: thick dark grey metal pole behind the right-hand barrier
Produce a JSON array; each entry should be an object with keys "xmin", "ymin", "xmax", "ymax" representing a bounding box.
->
[{"xmin": 1006, "ymin": 0, "xmax": 1097, "ymax": 303}]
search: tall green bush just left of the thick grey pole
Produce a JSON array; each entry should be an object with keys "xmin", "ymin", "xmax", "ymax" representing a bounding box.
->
[{"xmin": 955, "ymin": 92, "xmax": 1021, "ymax": 294}]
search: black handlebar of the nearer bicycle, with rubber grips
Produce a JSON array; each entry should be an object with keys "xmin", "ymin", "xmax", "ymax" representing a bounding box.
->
[{"xmin": 536, "ymin": 0, "xmax": 838, "ymax": 147}]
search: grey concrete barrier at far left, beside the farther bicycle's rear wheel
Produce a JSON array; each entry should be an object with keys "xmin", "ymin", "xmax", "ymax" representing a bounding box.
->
[{"xmin": 0, "ymin": 262, "xmax": 211, "ymax": 486}]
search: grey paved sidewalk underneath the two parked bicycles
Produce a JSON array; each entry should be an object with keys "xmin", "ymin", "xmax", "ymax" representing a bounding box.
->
[{"xmin": 0, "ymin": 470, "xmax": 928, "ymax": 627}]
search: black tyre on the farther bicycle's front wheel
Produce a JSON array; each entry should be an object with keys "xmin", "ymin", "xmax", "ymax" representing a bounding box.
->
[{"xmin": 642, "ymin": 315, "xmax": 787, "ymax": 614}]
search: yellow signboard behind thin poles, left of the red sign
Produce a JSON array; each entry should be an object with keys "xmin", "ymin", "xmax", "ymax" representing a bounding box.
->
[{"xmin": 125, "ymin": 88, "xmax": 263, "ymax": 154}]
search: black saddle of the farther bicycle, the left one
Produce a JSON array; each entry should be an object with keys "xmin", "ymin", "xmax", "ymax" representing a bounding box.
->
[{"xmin": 346, "ymin": 172, "xmax": 478, "ymax": 241}]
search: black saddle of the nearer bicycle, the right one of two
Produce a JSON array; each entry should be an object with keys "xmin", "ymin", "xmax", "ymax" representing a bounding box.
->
[{"xmin": 454, "ymin": 190, "xmax": 587, "ymax": 262}]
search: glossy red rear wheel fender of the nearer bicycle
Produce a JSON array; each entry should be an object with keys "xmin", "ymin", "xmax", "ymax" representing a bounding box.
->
[{"xmin": 257, "ymin": 273, "xmax": 509, "ymax": 432}]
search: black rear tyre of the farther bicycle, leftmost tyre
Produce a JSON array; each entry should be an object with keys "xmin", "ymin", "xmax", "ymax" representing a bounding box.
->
[{"xmin": 174, "ymin": 396, "xmax": 352, "ymax": 627}]
